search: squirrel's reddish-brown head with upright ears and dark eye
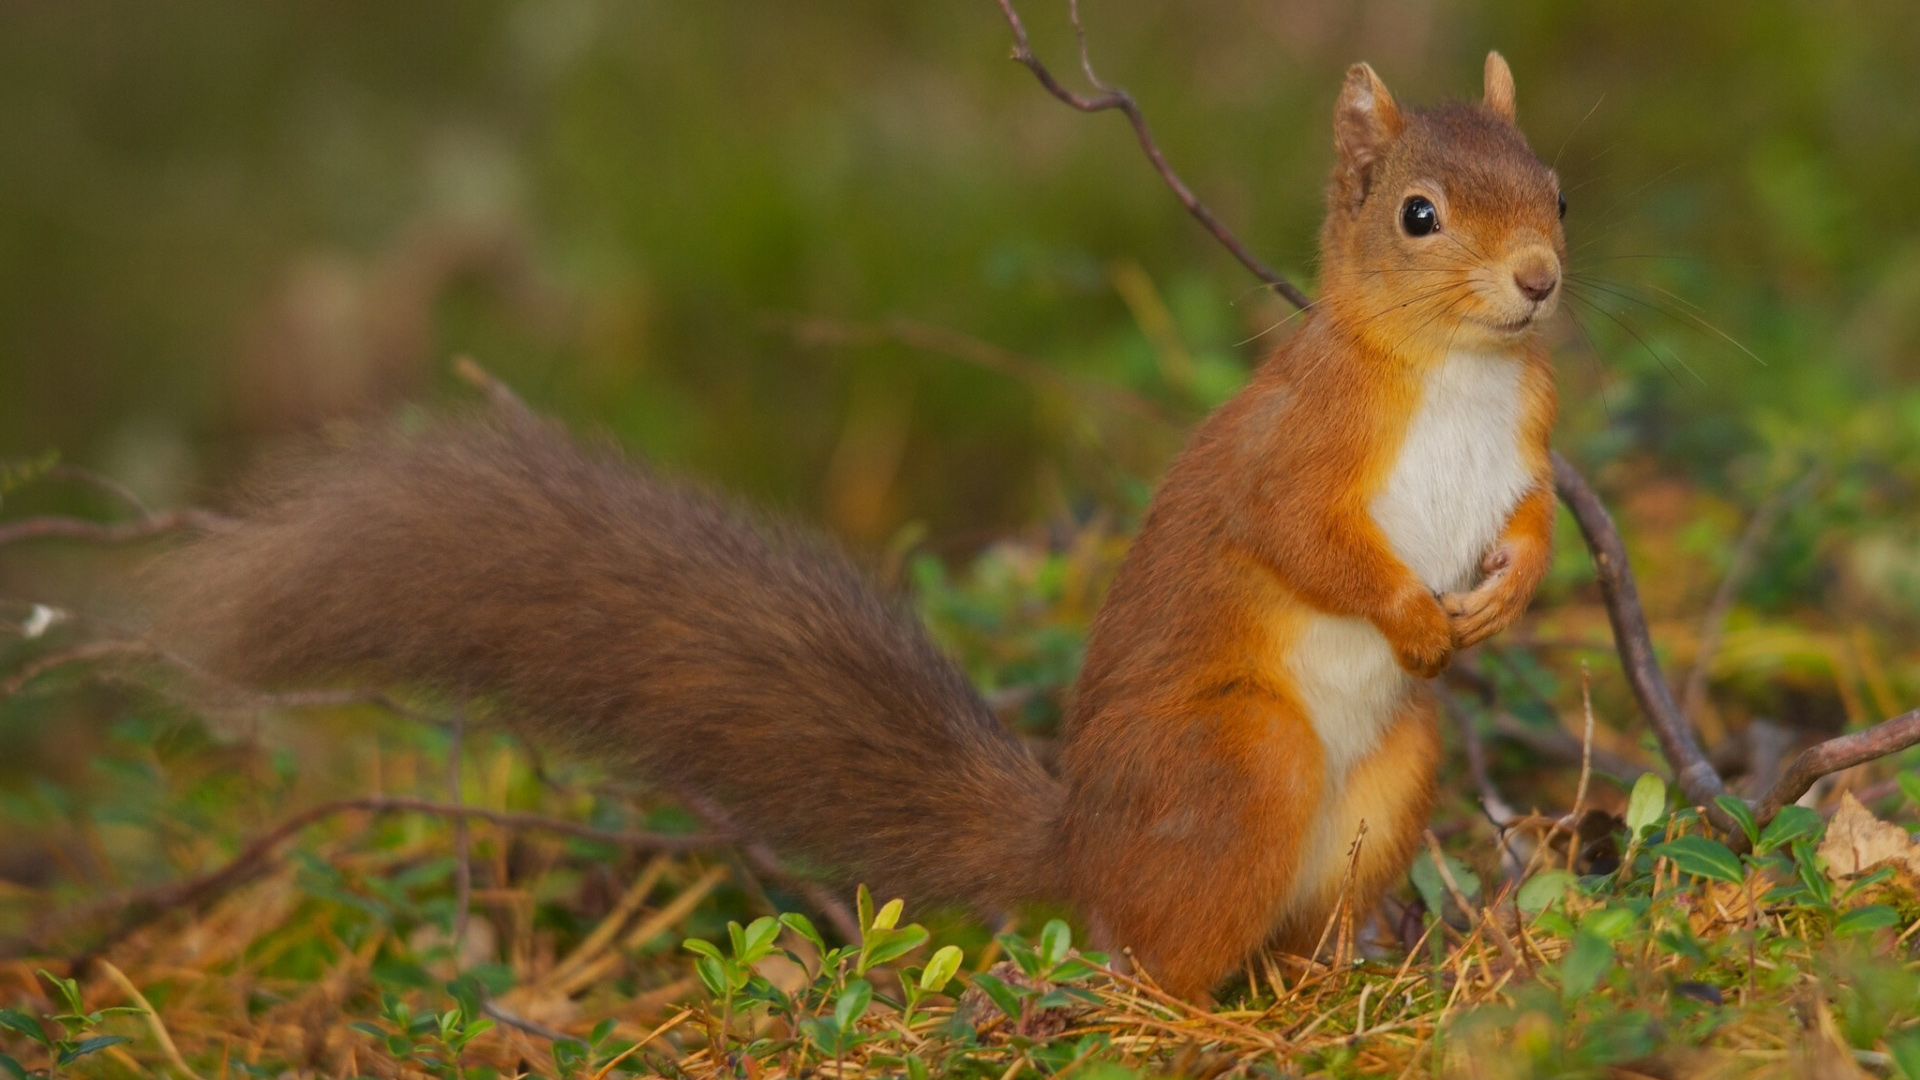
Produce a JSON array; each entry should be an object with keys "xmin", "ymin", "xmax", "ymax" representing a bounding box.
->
[{"xmin": 1321, "ymin": 52, "xmax": 1567, "ymax": 354}]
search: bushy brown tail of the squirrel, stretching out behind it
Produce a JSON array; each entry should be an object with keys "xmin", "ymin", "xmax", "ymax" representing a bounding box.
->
[{"xmin": 159, "ymin": 417, "xmax": 1062, "ymax": 907}]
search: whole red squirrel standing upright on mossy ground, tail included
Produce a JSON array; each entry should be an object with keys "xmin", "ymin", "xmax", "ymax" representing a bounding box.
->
[{"xmin": 157, "ymin": 54, "xmax": 1567, "ymax": 999}]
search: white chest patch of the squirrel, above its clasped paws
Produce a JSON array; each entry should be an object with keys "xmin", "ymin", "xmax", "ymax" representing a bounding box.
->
[{"xmin": 1371, "ymin": 352, "xmax": 1532, "ymax": 592}]
